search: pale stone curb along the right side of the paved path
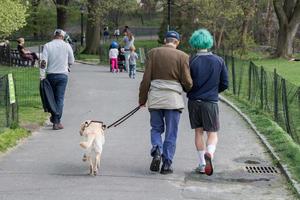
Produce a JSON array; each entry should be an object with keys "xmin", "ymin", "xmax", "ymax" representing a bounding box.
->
[{"xmin": 219, "ymin": 95, "xmax": 300, "ymax": 197}]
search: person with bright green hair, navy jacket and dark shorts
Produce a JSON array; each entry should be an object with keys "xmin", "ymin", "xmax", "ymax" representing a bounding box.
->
[{"xmin": 187, "ymin": 29, "xmax": 228, "ymax": 176}]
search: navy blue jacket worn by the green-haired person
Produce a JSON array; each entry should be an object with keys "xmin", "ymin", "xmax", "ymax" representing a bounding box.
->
[{"xmin": 187, "ymin": 52, "xmax": 228, "ymax": 102}]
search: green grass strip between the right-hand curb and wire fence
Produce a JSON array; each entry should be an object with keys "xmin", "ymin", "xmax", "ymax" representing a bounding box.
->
[{"xmin": 226, "ymin": 93, "xmax": 300, "ymax": 186}]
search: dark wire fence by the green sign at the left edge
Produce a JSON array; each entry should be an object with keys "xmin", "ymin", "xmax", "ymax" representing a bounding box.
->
[{"xmin": 0, "ymin": 75, "xmax": 18, "ymax": 129}]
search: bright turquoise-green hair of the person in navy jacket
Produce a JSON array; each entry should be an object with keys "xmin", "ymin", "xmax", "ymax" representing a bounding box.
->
[{"xmin": 189, "ymin": 29, "xmax": 214, "ymax": 49}]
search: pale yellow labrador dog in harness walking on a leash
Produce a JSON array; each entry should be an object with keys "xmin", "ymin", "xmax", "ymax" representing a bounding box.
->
[{"xmin": 79, "ymin": 120, "xmax": 106, "ymax": 176}]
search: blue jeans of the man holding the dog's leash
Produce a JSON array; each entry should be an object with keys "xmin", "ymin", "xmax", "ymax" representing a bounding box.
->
[{"xmin": 150, "ymin": 109, "xmax": 180, "ymax": 165}]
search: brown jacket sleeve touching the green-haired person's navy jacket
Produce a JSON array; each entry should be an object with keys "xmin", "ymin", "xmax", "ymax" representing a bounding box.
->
[{"xmin": 180, "ymin": 56, "xmax": 193, "ymax": 92}]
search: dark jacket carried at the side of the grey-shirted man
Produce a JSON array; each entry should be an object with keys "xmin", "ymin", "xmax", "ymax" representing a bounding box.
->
[{"xmin": 40, "ymin": 79, "xmax": 58, "ymax": 115}]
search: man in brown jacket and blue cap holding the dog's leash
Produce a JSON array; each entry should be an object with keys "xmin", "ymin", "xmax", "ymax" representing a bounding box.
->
[{"xmin": 139, "ymin": 31, "xmax": 193, "ymax": 174}]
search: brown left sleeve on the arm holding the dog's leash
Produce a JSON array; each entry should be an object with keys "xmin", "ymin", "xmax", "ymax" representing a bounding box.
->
[{"xmin": 139, "ymin": 51, "xmax": 152, "ymax": 105}]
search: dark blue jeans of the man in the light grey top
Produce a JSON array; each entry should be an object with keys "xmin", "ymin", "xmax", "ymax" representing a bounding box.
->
[{"xmin": 47, "ymin": 74, "xmax": 68, "ymax": 124}]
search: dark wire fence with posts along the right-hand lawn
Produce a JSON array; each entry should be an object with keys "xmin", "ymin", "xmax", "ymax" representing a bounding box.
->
[{"xmin": 224, "ymin": 56, "xmax": 300, "ymax": 144}]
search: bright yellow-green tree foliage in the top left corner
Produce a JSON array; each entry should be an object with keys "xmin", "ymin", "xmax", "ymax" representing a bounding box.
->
[{"xmin": 0, "ymin": 0, "xmax": 27, "ymax": 39}]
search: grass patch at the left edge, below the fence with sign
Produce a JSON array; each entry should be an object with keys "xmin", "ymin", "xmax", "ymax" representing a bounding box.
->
[{"xmin": 0, "ymin": 128, "xmax": 31, "ymax": 152}]
